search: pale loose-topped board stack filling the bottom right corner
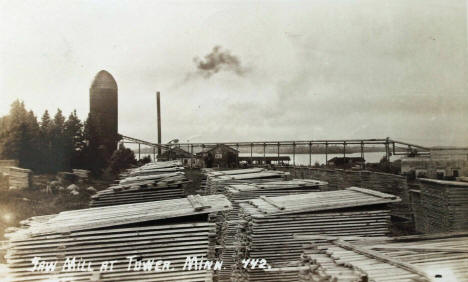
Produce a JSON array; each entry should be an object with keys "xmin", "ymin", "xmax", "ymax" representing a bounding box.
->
[{"xmin": 300, "ymin": 233, "xmax": 468, "ymax": 282}]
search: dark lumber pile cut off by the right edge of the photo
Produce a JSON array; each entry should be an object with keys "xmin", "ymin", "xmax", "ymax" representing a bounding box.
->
[{"xmin": 412, "ymin": 179, "xmax": 468, "ymax": 233}]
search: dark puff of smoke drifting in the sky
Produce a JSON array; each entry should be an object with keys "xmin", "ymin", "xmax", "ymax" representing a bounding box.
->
[{"xmin": 193, "ymin": 46, "xmax": 247, "ymax": 78}]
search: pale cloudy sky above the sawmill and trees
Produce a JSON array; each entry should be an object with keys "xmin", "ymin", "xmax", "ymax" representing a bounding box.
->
[{"xmin": 0, "ymin": 0, "xmax": 468, "ymax": 146}]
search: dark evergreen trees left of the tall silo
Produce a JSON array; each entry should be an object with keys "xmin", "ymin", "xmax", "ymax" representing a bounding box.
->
[{"xmin": 0, "ymin": 100, "xmax": 136, "ymax": 174}]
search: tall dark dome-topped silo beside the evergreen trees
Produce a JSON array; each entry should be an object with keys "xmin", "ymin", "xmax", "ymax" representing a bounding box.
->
[{"xmin": 89, "ymin": 70, "xmax": 118, "ymax": 154}]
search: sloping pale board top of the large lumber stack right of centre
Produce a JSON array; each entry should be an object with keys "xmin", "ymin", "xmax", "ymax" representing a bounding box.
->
[{"xmin": 243, "ymin": 187, "xmax": 401, "ymax": 214}]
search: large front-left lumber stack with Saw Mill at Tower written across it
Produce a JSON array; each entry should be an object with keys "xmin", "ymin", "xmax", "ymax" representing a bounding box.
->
[{"xmin": 5, "ymin": 195, "xmax": 231, "ymax": 281}]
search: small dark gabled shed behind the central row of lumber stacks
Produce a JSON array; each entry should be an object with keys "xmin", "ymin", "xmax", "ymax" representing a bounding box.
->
[{"xmin": 197, "ymin": 144, "xmax": 239, "ymax": 168}]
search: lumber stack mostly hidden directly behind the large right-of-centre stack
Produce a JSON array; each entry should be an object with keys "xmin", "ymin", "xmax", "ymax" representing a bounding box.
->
[{"xmin": 218, "ymin": 179, "xmax": 327, "ymax": 281}]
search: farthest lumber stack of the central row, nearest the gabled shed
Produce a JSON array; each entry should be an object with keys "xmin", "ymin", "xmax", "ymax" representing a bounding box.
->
[{"xmin": 204, "ymin": 168, "xmax": 289, "ymax": 195}]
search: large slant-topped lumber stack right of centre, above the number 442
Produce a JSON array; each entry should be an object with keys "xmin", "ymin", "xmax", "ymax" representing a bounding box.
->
[{"xmin": 233, "ymin": 187, "xmax": 400, "ymax": 281}]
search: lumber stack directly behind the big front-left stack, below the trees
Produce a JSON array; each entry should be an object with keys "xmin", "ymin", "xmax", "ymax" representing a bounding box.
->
[{"xmin": 90, "ymin": 172, "xmax": 190, "ymax": 207}]
